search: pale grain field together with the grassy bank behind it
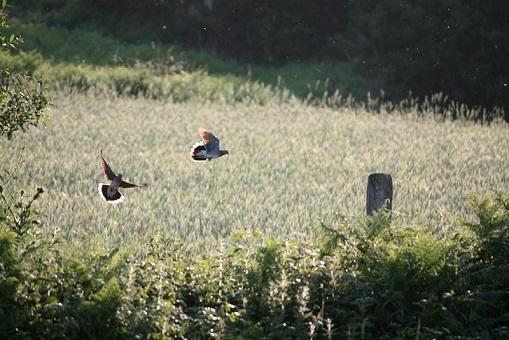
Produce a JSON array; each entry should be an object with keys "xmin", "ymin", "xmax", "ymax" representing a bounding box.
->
[{"xmin": 0, "ymin": 10, "xmax": 509, "ymax": 255}]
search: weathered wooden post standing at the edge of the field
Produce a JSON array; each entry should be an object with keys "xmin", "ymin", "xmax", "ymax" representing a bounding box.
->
[{"xmin": 366, "ymin": 173, "xmax": 392, "ymax": 215}]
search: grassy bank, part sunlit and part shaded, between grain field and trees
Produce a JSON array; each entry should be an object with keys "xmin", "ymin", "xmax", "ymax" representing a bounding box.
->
[{"xmin": 4, "ymin": 18, "xmax": 504, "ymax": 123}]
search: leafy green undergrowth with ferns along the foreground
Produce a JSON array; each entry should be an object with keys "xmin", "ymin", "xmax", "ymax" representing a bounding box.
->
[{"xmin": 0, "ymin": 183, "xmax": 509, "ymax": 339}]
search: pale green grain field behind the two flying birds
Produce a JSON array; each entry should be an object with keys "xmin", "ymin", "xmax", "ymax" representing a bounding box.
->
[{"xmin": 0, "ymin": 87, "xmax": 509, "ymax": 255}]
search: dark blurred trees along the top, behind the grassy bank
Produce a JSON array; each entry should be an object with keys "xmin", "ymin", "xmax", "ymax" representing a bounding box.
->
[{"xmin": 6, "ymin": 0, "xmax": 509, "ymax": 118}]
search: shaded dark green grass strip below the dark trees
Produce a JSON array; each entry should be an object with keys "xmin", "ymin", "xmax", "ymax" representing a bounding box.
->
[{"xmin": 0, "ymin": 18, "xmax": 351, "ymax": 98}]
